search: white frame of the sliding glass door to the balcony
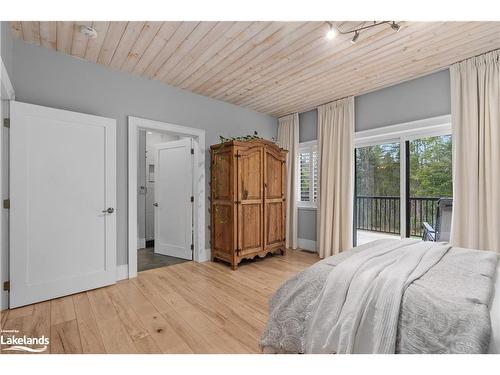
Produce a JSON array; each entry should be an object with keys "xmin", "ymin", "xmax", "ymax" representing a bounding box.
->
[{"xmin": 352, "ymin": 115, "xmax": 453, "ymax": 246}]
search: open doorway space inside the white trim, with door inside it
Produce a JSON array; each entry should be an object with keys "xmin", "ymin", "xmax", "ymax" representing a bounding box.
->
[{"xmin": 137, "ymin": 130, "xmax": 194, "ymax": 272}]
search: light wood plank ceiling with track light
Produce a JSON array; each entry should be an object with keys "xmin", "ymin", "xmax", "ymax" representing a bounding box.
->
[{"xmin": 11, "ymin": 21, "xmax": 500, "ymax": 117}]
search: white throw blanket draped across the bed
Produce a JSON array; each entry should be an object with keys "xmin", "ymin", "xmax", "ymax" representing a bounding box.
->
[{"xmin": 306, "ymin": 239, "xmax": 451, "ymax": 353}]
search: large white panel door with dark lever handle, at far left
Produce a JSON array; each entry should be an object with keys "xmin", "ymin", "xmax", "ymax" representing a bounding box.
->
[{"xmin": 10, "ymin": 102, "xmax": 116, "ymax": 307}]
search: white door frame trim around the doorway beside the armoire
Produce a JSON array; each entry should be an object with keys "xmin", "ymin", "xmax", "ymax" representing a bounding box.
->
[{"xmin": 128, "ymin": 116, "xmax": 209, "ymax": 278}]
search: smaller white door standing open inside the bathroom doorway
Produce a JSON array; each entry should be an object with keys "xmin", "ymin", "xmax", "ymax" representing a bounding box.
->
[{"xmin": 155, "ymin": 138, "xmax": 193, "ymax": 259}]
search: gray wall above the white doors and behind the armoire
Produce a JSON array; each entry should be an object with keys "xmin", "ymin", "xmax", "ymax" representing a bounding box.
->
[{"xmin": 11, "ymin": 40, "xmax": 277, "ymax": 265}]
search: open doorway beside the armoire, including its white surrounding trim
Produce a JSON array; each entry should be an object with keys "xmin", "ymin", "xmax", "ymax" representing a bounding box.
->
[{"xmin": 129, "ymin": 117, "xmax": 208, "ymax": 277}]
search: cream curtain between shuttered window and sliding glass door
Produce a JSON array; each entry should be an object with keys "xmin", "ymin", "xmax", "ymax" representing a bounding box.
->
[{"xmin": 317, "ymin": 97, "xmax": 354, "ymax": 258}]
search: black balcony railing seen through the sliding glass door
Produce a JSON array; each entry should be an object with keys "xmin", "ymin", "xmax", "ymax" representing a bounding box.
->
[{"xmin": 355, "ymin": 195, "xmax": 439, "ymax": 237}]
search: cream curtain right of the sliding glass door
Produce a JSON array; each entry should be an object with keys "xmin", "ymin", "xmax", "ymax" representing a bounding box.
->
[{"xmin": 450, "ymin": 50, "xmax": 500, "ymax": 252}]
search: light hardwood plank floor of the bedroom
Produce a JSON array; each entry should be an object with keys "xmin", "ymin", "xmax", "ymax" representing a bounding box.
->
[{"xmin": 1, "ymin": 251, "xmax": 319, "ymax": 353}]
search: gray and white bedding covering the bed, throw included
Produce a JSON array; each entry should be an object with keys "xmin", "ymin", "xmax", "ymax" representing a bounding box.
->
[{"xmin": 260, "ymin": 240, "xmax": 500, "ymax": 354}]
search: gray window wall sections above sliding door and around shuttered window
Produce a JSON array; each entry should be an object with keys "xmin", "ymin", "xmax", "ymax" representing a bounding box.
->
[{"xmin": 298, "ymin": 69, "xmax": 451, "ymax": 241}]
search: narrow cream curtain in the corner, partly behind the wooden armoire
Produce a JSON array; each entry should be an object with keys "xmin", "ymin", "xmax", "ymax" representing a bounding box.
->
[{"xmin": 278, "ymin": 113, "xmax": 299, "ymax": 249}]
